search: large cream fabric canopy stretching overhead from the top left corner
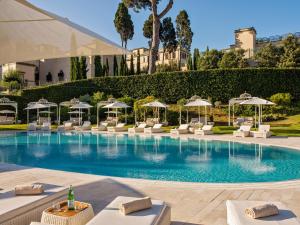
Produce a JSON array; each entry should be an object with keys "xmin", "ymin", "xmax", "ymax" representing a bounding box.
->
[{"xmin": 0, "ymin": 0, "xmax": 125, "ymax": 64}]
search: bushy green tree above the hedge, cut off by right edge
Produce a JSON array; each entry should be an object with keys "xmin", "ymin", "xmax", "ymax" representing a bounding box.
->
[{"xmin": 278, "ymin": 35, "xmax": 300, "ymax": 68}]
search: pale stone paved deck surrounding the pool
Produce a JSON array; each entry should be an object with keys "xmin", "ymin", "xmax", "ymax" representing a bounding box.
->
[{"xmin": 0, "ymin": 135, "xmax": 300, "ymax": 225}]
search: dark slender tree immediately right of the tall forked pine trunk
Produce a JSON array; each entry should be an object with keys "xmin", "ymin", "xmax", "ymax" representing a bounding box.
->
[{"xmin": 160, "ymin": 17, "xmax": 178, "ymax": 64}]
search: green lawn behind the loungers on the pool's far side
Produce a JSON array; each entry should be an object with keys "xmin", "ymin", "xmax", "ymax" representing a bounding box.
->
[{"xmin": 0, "ymin": 114, "xmax": 300, "ymax": 137}]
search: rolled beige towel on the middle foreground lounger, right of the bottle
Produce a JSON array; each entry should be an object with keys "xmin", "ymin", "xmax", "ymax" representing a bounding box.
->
[{"xmin": 119, "ymin": 197, "xmax": 152, "ymax": 215}]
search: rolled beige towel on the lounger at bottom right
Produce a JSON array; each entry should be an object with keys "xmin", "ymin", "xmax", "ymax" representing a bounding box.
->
[{"xmin": 245, "ymin": 204, "xmax": 279, "ymax": 219}]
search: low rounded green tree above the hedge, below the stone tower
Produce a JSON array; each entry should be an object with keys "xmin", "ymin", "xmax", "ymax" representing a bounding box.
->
[{"xmin": 219, "ymin": 49, "xmax": 248, "ymax": 68}]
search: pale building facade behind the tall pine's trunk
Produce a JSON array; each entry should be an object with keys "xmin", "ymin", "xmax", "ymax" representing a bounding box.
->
[{"xmin": 127, "ymin": 48, "xmax": 188, "ymax": 73}]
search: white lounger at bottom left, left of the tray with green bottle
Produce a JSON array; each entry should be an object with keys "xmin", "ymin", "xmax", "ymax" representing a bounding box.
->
[{"xmin": 0, "ymin": 184, "xmax": 67, "ymax": 225}]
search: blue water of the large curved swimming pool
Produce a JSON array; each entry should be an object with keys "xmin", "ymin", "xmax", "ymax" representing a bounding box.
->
[{"xmin": 0, "ymin": 133, "xmax": 300, "ymax": 183}]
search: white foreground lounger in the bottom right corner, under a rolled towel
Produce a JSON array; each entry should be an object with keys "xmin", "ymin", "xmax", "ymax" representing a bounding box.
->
[{"xmin": 226, "ymin": 201, "xmax": 300, "ymax": 225}]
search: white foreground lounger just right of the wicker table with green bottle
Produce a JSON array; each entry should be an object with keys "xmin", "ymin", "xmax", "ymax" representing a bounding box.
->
[{"xmin": 86, "ymin": 196, "xmax": 171, "ymax": 225}]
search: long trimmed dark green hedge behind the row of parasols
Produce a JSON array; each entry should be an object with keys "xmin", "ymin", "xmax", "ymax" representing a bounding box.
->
[{"xmin": 22, "ymin": 69, "xmax": 300, "ymax": 103}]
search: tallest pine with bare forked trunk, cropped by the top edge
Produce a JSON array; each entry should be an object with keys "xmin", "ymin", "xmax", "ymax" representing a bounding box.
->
[{"xmin": 123, "ymin": 0, "xmax": 174, "ymax": 74}]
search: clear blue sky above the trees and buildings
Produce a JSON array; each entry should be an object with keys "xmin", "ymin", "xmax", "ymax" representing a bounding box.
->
[{"xmin": 29, "ymin": 0, "xmax": 300, "ymax": 50}]
